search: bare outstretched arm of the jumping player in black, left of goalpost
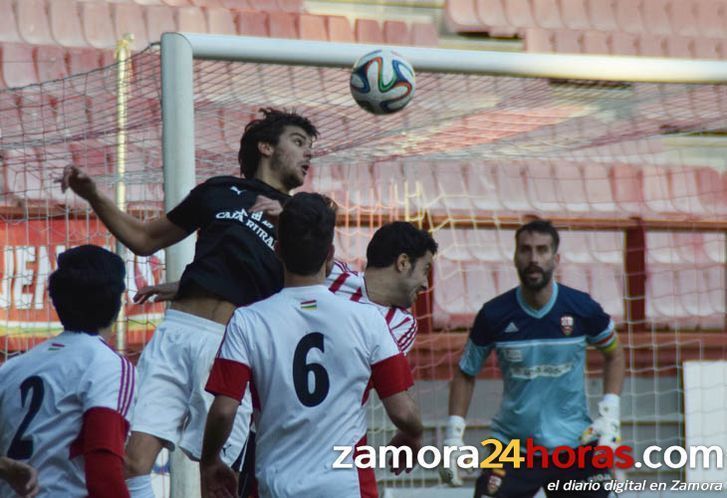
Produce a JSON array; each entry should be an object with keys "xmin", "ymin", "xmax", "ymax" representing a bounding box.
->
[{"xmin": 60, "ymin": 166, "xmax": 188, "ymax": 256}]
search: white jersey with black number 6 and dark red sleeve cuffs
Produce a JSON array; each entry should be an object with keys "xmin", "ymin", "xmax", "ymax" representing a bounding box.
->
[{"xmin": 208, "ymin": 285, "xmax": 413, "ymax": 498}]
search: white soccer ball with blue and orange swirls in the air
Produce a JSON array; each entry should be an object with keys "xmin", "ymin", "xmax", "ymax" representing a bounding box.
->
[{"xmin": 351, "ymin": 49, "xmax": 414, "ymax": 114}]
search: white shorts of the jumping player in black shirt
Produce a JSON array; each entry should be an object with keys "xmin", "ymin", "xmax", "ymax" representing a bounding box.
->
[{"xmin": 131, "ymin": 310, "xmax": 252, "ymax": 470}]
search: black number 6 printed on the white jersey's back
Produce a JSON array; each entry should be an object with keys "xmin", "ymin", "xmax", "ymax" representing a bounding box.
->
[{"xmin": 293, "ymin": 332, "xmax": 330, "ymax": 407}]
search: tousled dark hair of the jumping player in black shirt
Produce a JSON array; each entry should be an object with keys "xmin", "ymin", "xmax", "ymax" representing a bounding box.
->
[{"xmin": 237, "ymin": 107, "xmax": 318, "ymax": 178}]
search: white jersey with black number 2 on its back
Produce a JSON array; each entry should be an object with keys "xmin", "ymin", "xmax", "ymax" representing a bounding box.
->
[{"xmin": 0, "ymin": 332, "xmax": 135, "ymax": 498}]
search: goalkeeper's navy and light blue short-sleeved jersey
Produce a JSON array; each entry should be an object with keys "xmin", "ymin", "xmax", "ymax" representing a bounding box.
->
[{"xmin": 459, "ymin": 282, "xmax": 616, "ymax": 449}]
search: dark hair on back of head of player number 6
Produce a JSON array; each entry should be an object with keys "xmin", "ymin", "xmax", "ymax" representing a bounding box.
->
[{"xmin": 278, "ymin": 192, "xmax": 336, "ymax": 276}]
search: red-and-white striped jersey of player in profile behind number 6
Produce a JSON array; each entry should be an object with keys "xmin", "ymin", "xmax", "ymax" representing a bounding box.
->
[{"xmin": 326, "ymin": 260, "xmax": 417, "ymax": 354}]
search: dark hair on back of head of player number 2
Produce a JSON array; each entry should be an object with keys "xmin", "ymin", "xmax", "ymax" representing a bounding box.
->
[{"xmin": 48, "ymin": 245, "xmax": 126, "ymax": 334}]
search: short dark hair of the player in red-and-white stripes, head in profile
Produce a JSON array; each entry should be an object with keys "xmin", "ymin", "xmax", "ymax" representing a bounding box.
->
[{"xmin": 366, "ymin": 221, "xmax": 438, "ymax": 268}]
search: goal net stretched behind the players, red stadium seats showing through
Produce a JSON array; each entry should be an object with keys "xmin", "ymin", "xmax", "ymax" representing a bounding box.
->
[{"xmin": 0, "ymin": 35, "xmax": 727, "ymax": 489}]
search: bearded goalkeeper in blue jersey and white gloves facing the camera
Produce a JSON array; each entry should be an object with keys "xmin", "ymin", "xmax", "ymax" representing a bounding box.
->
[{"xmin": 441, "ymin": 220, "xmax": 625, "ymax": 498}]
